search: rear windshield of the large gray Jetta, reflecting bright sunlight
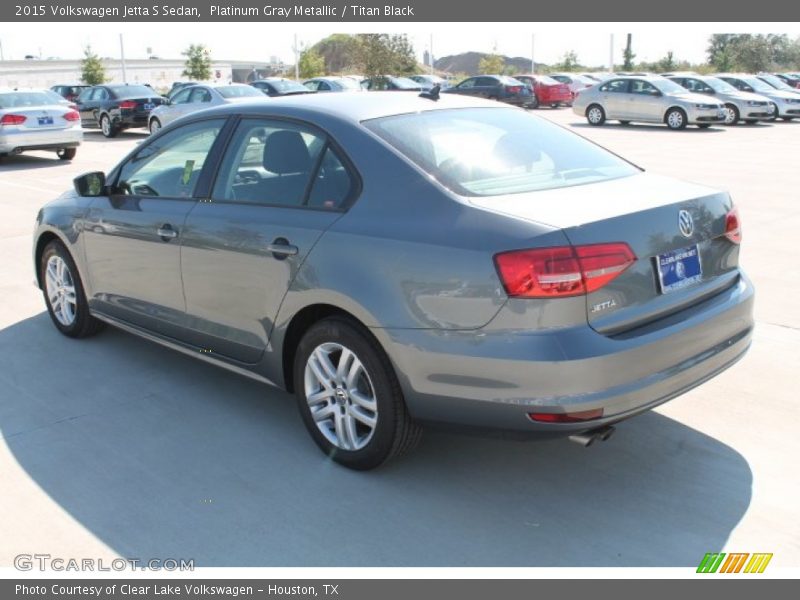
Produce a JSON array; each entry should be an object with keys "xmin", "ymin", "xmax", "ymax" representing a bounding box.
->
[{"xmin": 363, "ymin": 108, "xmax": 638, "ymax": 196}]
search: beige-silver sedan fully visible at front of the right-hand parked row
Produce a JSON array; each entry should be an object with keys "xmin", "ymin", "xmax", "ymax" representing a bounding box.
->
[{"xmin": 572, "ymin": 75, "xmax": 725, "ymax": 129}]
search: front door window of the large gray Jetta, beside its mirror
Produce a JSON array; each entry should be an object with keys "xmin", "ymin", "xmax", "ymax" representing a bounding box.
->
[{"xmin": 114, "ymin": 119, "xmax": 225, "ymax": 198}]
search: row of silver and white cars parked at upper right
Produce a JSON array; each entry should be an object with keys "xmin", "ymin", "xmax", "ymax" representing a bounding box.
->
[{"xmin": 573, "ymin": 72, "xmax": 800, "ymax": 129}]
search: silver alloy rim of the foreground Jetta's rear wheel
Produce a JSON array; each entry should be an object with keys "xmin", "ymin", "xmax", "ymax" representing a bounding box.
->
[{"xmin": 304, "ymin": 342, "xmax": 378, "ymax": 451}]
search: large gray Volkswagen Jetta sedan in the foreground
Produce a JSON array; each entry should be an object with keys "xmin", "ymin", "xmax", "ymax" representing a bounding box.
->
[{"xmin": 33, "ymin": 94, "xmax": 753, "ymax": 469}]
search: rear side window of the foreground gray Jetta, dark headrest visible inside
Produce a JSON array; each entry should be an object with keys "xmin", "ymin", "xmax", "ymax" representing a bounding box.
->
[{"xmin": 212, "ymin": 119, "xmax": 353, "ymax": 209}]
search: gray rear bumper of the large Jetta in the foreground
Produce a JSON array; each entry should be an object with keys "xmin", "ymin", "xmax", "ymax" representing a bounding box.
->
[{"xmin": 383, "ymin": 275, "xmax": 754, "ymax": 435}]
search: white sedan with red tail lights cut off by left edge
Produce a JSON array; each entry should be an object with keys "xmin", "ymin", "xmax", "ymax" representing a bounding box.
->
[{"xmin": 0, "ymin": 90, "xmax": 83, "ymax": 160}]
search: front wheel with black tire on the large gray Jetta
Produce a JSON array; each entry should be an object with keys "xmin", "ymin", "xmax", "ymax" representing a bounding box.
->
[{"xmin": 39, "ymin": 240, "xmax": 103, "ymax": 338}]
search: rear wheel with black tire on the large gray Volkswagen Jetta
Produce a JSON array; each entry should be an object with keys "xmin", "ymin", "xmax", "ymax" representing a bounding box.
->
[{"xmin": 294, "ymin": 317, "xmax": 422, "ymax": 471}]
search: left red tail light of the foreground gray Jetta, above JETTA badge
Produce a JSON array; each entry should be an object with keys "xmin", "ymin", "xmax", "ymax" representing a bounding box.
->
[{"xmin": 494, "ymin": 242, "xmax": 636, "ymax": 298}]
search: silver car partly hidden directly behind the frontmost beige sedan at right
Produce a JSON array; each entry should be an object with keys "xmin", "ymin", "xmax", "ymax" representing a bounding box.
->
[{"xmin": 669, "ymin": 73, "xmax": 775, "ymax": 125}]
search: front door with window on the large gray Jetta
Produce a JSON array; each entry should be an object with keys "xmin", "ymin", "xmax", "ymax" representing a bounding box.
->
[{"xmin": 83, "ymin": 118, "xmax": 225, "ymax": 338}]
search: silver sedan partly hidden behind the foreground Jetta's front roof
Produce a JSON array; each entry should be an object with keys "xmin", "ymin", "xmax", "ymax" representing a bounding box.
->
[{"xmin": 147, "ymin": 83, "xmax": 264, "ymax": 133}]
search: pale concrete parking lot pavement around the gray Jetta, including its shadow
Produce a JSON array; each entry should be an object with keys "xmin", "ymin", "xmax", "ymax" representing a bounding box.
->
[{"xmin": 0, "ymin": 115, "xmax": 800, "ymax": 567}]
